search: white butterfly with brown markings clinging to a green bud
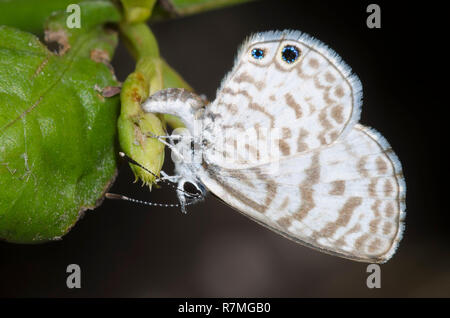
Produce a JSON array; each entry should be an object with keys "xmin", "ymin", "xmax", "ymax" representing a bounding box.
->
[{"xmin": 142, "ymin": 30, "xmax": 406, "ymax": 263}]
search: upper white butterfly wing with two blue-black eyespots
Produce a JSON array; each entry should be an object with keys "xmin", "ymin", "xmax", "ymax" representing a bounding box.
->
[{"xmin": 205, "ymin": 31, "xmax": 361, "ymax": 168}]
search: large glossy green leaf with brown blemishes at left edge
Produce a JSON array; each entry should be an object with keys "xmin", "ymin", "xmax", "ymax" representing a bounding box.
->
[{"xmin": 0, "ymin": 2, "xmax": 120, "ymax": 243}]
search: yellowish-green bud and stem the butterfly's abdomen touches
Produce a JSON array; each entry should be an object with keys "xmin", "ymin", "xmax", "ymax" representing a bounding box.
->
[{"xmin": 118, "ymin": 23, "xmax": 164, "ymax": 186}]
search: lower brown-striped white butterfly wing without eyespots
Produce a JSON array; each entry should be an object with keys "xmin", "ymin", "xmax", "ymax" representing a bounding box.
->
[{"xmin": 201, "ymin": 125, "xmax": 406, "ymax": 263}]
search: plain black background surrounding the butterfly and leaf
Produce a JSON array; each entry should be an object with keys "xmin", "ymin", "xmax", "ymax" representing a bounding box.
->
[{"xmin": 0, "ymin": 1, "xmax": 450, "ymax": 297}]
